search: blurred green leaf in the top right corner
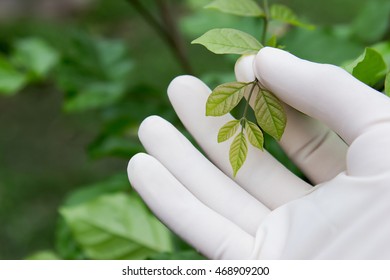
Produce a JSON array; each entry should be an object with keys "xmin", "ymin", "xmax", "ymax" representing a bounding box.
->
[{"xmin": 352, "ymin": 0, "xmax": 390, "ymax": 42}]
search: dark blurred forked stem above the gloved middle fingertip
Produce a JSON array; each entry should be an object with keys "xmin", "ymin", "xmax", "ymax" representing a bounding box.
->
[{"xmin": 126, "ymin": 0, "xmax": 194, "ymax": 75}]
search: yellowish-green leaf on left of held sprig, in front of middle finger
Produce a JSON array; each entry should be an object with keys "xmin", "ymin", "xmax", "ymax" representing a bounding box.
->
[{"xmin": 206, "ymin": 82, "xmax": 250, "ymax": 116}]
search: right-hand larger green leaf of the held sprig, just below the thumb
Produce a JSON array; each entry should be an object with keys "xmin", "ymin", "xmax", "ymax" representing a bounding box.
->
[{"xmin": 255, "ymin": 90, "xmax": 287, "ymax": 140}]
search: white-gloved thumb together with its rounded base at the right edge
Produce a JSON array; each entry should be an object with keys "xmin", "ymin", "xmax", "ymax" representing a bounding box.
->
[{"xmin": 254, "ymin": 48, "xmax": 390, "ymax": 176}]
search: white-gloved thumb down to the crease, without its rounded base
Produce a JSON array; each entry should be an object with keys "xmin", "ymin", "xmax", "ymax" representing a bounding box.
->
[{"xmin": 254, "ymin": 47, "xmax": 390, "ymax": 144}]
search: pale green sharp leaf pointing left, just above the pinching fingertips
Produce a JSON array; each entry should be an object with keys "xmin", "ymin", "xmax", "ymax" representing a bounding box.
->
[{"xmin": 192, "ymin": 28, "xmax": 263, "ymax": 54}]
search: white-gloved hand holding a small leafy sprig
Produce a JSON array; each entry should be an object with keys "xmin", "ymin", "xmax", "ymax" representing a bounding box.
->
[{"xmin": 128, "ymin": 48, "xmax": 390, "ymax": 259}]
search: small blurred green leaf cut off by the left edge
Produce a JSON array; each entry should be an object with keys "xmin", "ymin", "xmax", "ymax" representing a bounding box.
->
[{"xmin": 0, "ymin": 56, "xmax": 27, "ymax": 95}]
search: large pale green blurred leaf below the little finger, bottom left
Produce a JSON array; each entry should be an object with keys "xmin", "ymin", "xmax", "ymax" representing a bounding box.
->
[{"xmin": 60, "ymin": 193, "xmax": 172, "ymax": 259}]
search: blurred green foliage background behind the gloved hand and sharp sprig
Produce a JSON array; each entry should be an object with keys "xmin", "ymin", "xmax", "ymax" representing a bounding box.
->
[{"xmin": 0, "ymin": 0, "xmax": 390, "ymax": 259}]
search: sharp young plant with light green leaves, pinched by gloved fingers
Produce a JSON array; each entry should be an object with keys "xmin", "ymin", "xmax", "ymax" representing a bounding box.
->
[{"xmin": 192, "ymin": 0, "xmax": 312, "ymax": 176}]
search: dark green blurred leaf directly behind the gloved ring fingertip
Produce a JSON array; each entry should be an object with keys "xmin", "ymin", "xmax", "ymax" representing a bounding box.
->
[{"xmin": 88, "ymin": 85, "xmax": 172, "ymax": 159}]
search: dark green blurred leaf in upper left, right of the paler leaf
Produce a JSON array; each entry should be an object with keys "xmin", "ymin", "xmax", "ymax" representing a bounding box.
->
[{"xmin": 57, "ymin": 34, "xmax": 133, "ymax": 112}]
